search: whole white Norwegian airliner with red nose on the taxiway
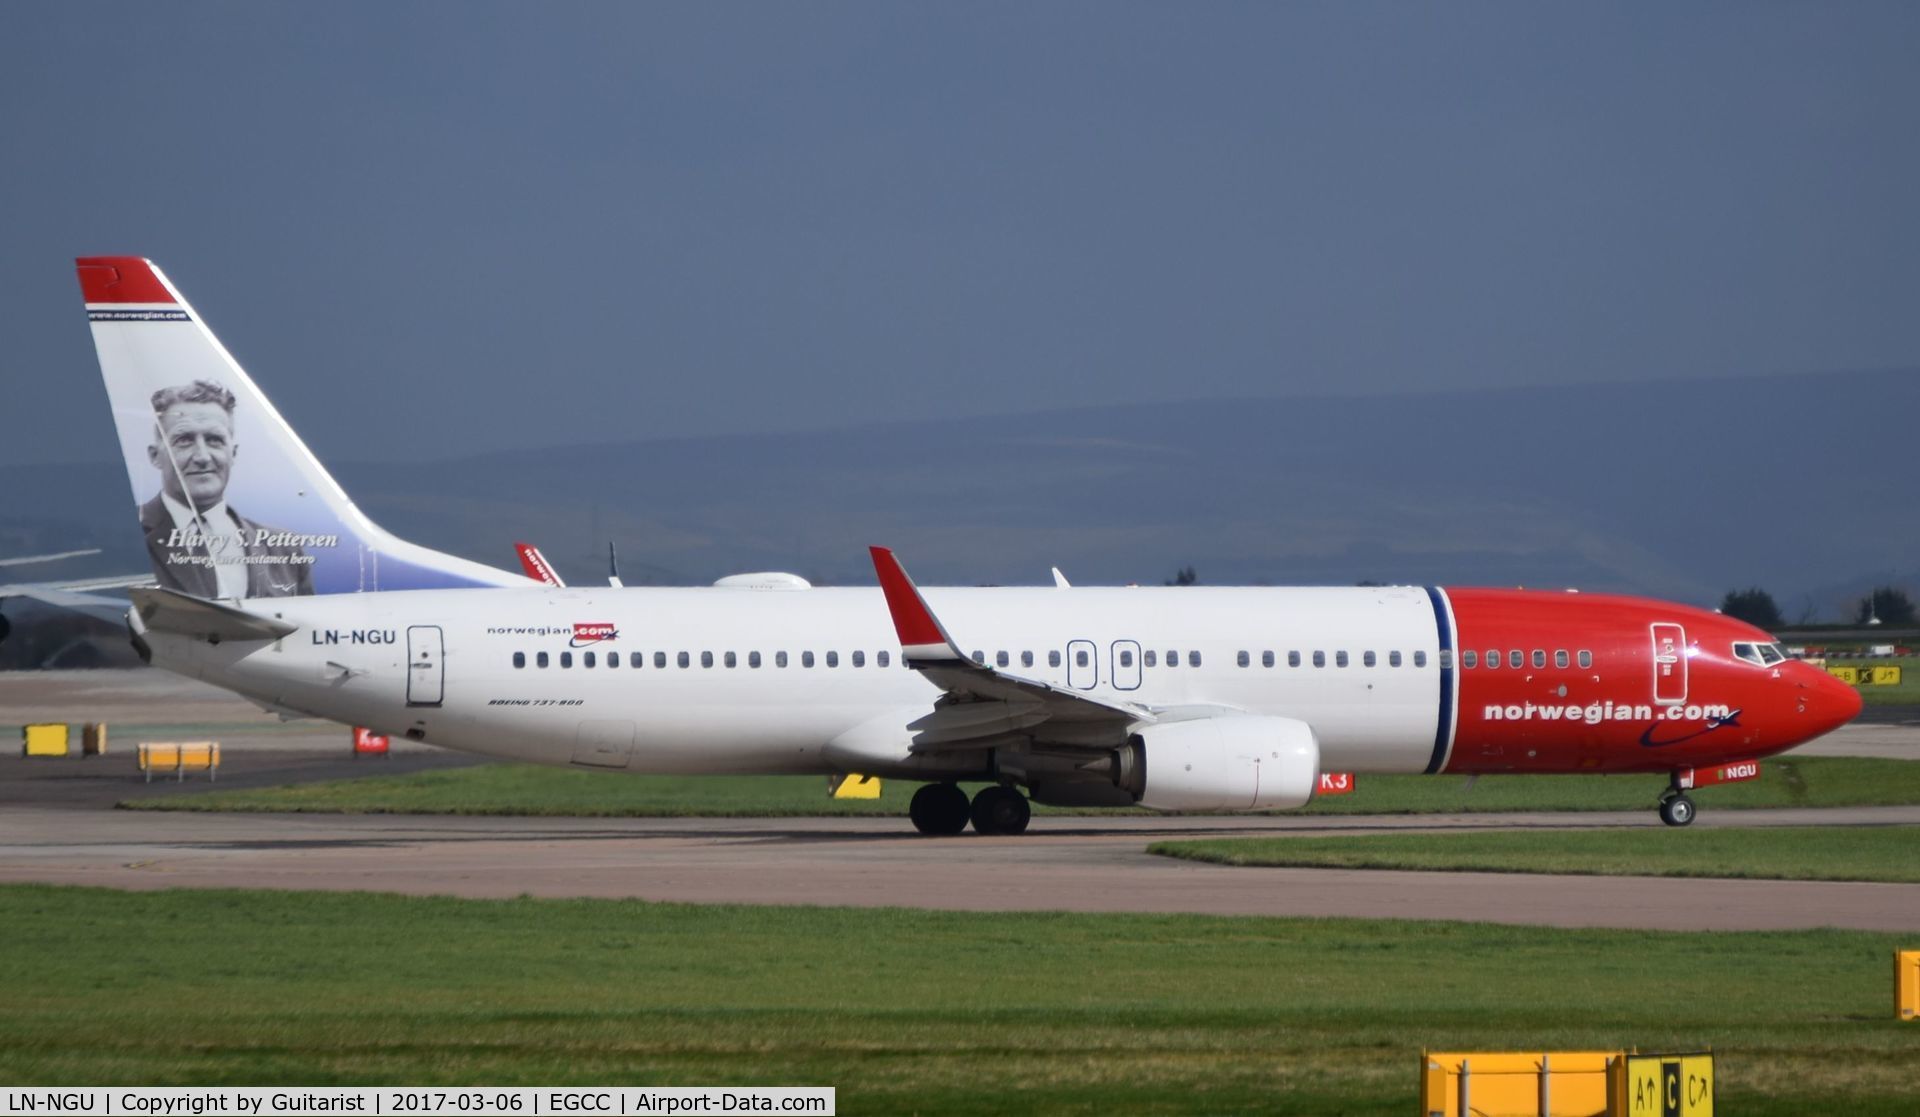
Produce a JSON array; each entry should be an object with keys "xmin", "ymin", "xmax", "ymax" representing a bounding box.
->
[{"xmin": 79, "ymin": 257, "xmax": 1860, "ymax": 835}]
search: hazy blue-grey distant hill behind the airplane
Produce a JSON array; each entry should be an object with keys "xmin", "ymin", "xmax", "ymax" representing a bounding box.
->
[{"xmin": 0, "ymin": 370, "xmax": 1920, "ymax": 620}]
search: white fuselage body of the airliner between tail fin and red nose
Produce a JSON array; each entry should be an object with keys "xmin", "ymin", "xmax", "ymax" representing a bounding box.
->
[{"xmin": 150, "ymin": 587, "xmax": 1452, "ymax": 777}]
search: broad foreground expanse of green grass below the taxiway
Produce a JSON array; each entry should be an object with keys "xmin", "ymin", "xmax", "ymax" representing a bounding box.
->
[{"xmin": 0, "ymin": 885, "xmax": 1920, "ymax": 1117}]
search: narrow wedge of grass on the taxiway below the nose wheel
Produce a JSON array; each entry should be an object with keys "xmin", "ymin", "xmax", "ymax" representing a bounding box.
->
[{"xmin": 1146, "ymin": 825, "xmax": 1920, "ymax": 879}]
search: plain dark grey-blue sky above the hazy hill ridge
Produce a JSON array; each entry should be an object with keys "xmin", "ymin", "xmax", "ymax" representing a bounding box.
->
[{"xmin": 0, "ymin": 4, "xmax": 1920, "ymax": 464}]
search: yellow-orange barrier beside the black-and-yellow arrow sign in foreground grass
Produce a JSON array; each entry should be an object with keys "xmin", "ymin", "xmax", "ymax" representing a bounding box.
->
[{"xmin": 1421, "ymin": 1052, "xmax": 1626, "ymax": 1117}]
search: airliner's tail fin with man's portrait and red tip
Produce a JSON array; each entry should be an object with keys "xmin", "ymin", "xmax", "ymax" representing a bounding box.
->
[{"xmin": 75, "ymin": 255, "xmax": 526, "ymax": 599}]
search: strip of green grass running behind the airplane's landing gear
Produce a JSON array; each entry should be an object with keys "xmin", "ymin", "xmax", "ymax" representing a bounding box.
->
[{"xmin": 121, "ymin": 756, "xmax": 1920, "ymax": 818}]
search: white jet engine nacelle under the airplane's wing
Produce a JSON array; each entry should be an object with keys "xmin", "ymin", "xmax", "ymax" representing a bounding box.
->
[{"xmin": 1114, "ymin": 716, "xmax": 1319, "ymax": 810}]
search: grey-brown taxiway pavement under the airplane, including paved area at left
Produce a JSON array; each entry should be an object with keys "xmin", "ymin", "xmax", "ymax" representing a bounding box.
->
[{"xmin": 0, "ymin": 672, "xmax": 1920, "ymax": 931}]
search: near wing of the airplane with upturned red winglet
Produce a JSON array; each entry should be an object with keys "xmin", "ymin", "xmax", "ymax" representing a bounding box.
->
[{"xmin": 868, "ymin": 547, "xmax": 1158, "ymax": 752}]
